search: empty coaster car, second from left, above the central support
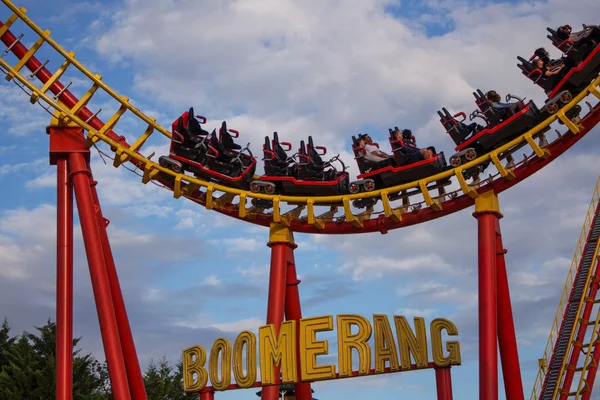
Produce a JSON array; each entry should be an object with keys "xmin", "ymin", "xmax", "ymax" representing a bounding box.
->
[{"xmin": 250, "ymin": 132, "xmax": 350, "ymax": 197}]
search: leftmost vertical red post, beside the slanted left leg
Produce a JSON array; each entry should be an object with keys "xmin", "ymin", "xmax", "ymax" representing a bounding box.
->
[{"xmin": 56, "ymin": 158, "xmax": 73, "ymax": 400}]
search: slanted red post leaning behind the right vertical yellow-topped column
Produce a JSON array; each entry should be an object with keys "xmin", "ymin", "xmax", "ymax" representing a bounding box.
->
[{"xmin": 496, "ymin": 219, "xmax": 524, "ymax": 400}]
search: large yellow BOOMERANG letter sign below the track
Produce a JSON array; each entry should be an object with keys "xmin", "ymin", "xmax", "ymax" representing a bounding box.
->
[{"xmin": 183, "ymin": 314, "xmax": 460, "ymax": 394}]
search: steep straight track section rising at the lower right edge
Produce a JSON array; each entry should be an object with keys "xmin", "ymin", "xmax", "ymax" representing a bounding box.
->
[{"xmin": 531, "ymin": 180, "xmax": 600, "ymax": 400}]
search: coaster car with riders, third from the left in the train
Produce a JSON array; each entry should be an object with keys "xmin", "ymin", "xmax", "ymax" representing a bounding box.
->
[{"xmin": 349, "ymin": 134, "xmax": 449, "ymax": 193}]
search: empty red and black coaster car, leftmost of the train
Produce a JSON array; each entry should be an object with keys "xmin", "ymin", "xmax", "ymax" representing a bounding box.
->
[{"xmin": 159, "ymin": 108, "xmax": 256, "ymax": 189}]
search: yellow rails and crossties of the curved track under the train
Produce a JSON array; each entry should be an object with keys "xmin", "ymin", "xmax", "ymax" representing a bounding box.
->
[{"xmin": 0, "ymin": 0, "xmax": 600, "ymax": 231}]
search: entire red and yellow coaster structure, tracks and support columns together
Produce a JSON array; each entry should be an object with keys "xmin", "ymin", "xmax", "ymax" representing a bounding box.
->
[{"xmin": 0, "ymin": 0, "xmax": 600, "ymax": 400}]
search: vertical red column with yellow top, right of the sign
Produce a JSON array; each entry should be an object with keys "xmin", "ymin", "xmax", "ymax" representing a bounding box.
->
[{"xmin": 473, "ymin": 191, "xmax": 502, "ymax": 400}]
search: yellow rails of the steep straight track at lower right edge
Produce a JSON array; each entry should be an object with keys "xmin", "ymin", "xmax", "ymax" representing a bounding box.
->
[{"xmin": 530, "ymin": 179, "xmax": 600, "ymax": 400}]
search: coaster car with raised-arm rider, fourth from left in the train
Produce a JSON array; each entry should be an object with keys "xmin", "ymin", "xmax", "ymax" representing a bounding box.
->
[{"xmin": 438, "ymin": 89, "xmax": 543, "ymax": 167}]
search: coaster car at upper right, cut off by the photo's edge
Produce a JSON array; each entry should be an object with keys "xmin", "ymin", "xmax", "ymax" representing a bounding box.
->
[{"xmin": 517, "ymin": 46, "xmax": 600, "ymax": 109}]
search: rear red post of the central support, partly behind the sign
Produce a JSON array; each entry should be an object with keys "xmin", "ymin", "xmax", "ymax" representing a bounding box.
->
[{"xmin": 285, "ymin": 243, "xmax": 312, "ymax": 400}]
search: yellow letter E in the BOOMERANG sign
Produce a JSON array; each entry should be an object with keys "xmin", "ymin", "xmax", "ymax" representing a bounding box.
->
[{"xmin": 300, "ymin": 315, "xmax": 335, "ymax": 381}]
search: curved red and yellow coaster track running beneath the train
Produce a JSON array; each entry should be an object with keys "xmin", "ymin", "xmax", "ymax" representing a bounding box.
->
[{"xmin": 0, "ymin": 0, "xmax": 600, "ymax": 234}]
